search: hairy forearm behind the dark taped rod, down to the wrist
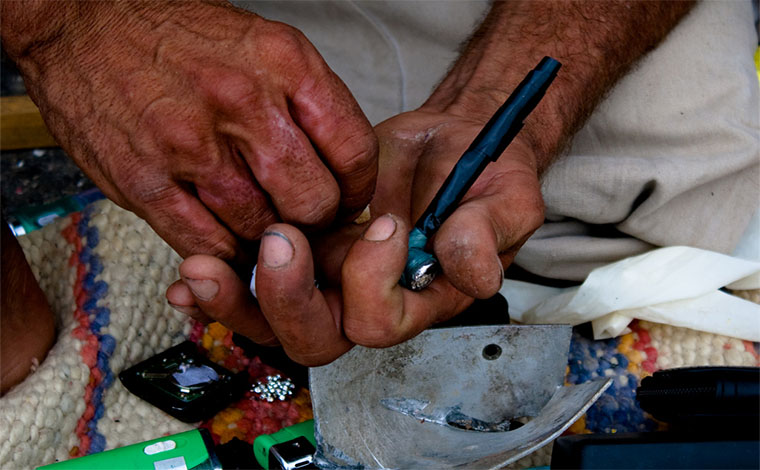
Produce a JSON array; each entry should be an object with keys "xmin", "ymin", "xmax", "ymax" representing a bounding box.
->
[{"xmin": 423, "ymin": 0, "xmax": 693, "ymax": 173}]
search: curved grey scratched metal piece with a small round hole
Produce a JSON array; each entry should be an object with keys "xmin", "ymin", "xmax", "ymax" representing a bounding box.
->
[{"xmin": 309, "ymin": 325, "xmax": 610, "ymax": 469}]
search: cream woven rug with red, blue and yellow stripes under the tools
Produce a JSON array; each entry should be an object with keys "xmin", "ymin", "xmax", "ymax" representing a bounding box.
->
[{"xmin": 0, "ymin": 201, "xmax": 760, "ymax": 469}]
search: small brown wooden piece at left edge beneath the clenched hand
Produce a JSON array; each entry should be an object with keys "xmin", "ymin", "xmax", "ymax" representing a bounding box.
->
[{"xmin": 0, "ymin": 95, "xmax": 58, "ymax": 150}]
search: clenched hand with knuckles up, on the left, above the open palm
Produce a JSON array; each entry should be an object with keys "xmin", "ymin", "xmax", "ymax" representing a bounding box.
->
[{"xmin": 3, "ymin": 1, "xmax": 377, "ymax": 260}]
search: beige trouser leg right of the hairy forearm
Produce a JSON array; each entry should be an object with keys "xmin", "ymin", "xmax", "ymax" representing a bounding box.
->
[{"xmin": 515, "ymin": 1, "xmax": 760, "ymax": 280}]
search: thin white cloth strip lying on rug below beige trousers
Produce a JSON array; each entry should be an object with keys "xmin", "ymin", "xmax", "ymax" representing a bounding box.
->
[{"xmin": 500, "ymin": 247, "xmax": 760, "ymax": 341}]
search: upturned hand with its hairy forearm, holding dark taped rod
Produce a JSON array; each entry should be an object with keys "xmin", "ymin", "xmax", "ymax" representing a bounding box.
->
[{"xmin": 167, "ymin": 0, "xmax": 691, "ymax": 365}]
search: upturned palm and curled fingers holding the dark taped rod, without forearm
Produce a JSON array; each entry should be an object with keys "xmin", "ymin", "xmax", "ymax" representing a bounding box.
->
[{"xmin": 167, "ymin": 111, "xmax": 543, "ymax": 365}]
